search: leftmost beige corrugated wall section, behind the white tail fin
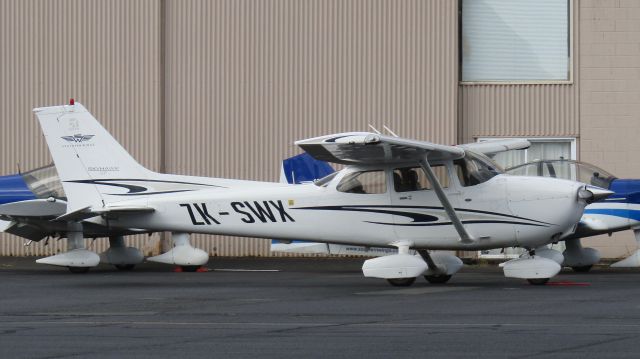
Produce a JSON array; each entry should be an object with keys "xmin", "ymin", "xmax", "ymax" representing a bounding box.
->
[{"xmin": 0, "ymin": 0, "xmax": 161, "ymax": 255}]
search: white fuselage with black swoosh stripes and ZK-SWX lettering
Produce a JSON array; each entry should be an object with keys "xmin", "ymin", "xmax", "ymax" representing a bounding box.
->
[{"xmin": 91, "ymin": 161, "xmax": 585, "ymax": 250}]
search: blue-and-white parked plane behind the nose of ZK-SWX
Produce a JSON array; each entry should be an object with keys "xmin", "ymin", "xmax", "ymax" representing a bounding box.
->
[{"xmin": 507, "ymin": 160, "xmax": 640, "ymax": 272}]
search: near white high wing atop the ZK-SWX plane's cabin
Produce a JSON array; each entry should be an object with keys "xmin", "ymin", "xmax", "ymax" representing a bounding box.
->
[{"xmin": 296, "ymin": 132, "xmax": 464, "ymax": 164}]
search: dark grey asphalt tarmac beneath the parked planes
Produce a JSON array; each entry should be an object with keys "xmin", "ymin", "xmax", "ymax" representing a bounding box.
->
[{"xmin": 0, "ymin": 257, "xmax": 640, "ymax": 358}]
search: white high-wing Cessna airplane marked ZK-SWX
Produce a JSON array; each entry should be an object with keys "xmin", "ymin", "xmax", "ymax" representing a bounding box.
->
[{"xmin": 34, "ymin": 103, "xmax": 610, "ymax": 285}]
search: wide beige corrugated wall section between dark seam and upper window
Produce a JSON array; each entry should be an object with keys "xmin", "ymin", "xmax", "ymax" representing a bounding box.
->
[{"xmin": 166, "ymin": 0, "xmax": 457, "ymax": 255}]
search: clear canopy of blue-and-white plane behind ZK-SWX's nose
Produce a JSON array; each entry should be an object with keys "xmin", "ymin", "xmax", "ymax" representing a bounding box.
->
[{"xmin": 507, "ymin": 160, "xmax": 616, "ymax": 188}]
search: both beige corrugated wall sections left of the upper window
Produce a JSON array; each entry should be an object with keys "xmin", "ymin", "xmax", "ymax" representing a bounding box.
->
[{"xmin": 0, "ymin": 0, "xmax": 457, "ymax": 255}]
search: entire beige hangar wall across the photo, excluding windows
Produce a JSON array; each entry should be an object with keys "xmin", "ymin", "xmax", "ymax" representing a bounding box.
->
[{"xmin": 0, "ymin": 0, "xmax": 640, "ymax": 255}]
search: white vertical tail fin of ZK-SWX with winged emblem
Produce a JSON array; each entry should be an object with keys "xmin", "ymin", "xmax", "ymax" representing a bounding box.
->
[{"xmin": 33, "ymin": 103, "xmax": 153, "ymax": 213}]
